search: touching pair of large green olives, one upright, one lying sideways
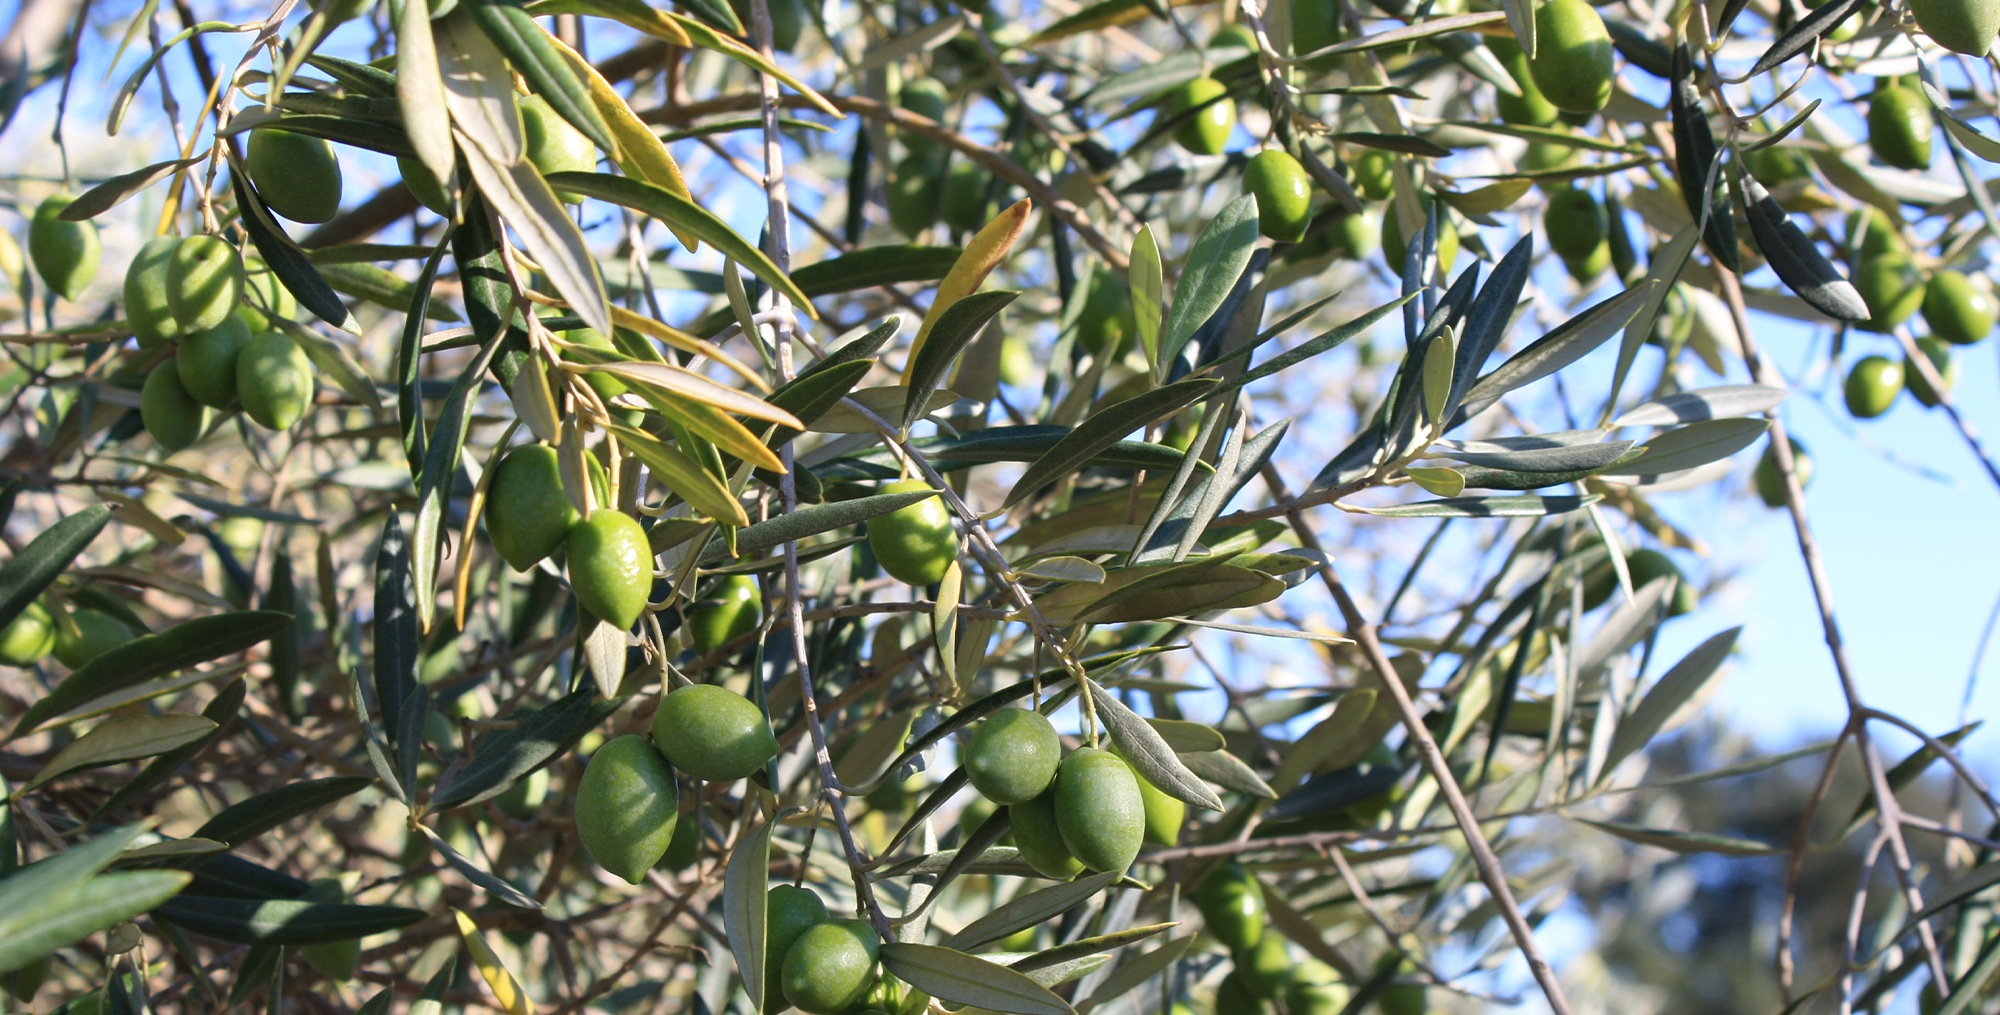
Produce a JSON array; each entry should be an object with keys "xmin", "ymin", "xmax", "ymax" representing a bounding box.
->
[{"xmin": 576, "ymin": 683, "xmax": 778, "ymax": 885}]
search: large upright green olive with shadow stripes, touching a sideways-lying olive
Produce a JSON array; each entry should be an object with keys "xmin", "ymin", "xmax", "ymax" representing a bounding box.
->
[{"xmin": 576, "ymin": 735, "xmax": 680, "ymax": 885}]
